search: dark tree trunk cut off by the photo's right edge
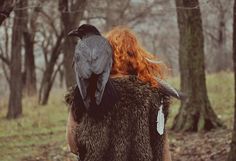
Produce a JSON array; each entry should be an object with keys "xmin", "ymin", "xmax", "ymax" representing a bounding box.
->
[{"xmin": 228, "ymin": 0, "xmax": 236, "ymax": 161}]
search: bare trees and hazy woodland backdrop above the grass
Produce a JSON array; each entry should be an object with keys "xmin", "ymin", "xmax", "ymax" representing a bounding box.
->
[{"xmin": 0, "ymin": 0, "xmax": 236, "ymax": 161}]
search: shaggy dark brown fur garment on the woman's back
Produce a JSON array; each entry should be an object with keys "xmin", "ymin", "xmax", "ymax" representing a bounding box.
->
[{"xmin": 66, "ymin": 77, "xmax": 169, "ymax": 161}]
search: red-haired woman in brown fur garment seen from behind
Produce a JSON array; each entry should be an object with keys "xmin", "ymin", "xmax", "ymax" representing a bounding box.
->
[{"xmin": 67, "ymin": 27, "xmax": 171, "ymax": 161}]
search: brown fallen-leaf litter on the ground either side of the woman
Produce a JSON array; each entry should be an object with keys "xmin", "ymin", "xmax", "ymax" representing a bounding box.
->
[{"xmin": 21, "ymin": 130, "xmax": 231, "ymax": 161}]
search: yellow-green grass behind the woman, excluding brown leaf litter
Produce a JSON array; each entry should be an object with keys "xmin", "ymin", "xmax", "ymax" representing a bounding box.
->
[{"xmin": 0, "ymin": 73, "xmax": 234, "ymax": 161}]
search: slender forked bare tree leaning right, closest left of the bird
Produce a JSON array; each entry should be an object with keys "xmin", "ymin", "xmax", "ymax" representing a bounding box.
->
[{"xmin": 38, "ymin": 11, "xmax": 64, "ymax": 105}]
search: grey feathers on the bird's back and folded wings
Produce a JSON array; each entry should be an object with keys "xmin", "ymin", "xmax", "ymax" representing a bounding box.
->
[{"xmin": 74, "ymin": 35, "xmax": 113, "ymax": 106}]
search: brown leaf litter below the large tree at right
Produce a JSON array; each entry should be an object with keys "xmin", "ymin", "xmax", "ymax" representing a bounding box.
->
[{"xmin": 170, "ymin": 129, "xmax": 231, "ymax": 161}]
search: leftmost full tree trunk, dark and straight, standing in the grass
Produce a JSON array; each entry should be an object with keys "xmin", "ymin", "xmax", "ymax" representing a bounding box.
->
[{"xmin": 7, "ymin": 0, "xmax": 24, "ymax": 118}]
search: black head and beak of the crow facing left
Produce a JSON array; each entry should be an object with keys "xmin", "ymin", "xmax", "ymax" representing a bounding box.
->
[{"xmin": 68, "ymin": 24, "xmax": 101, "ymax": 39}]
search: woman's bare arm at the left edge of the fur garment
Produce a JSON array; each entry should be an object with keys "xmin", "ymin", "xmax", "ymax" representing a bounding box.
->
[{"xmin": 66, "ymin": 111, "xmax": 78, "ymax": 155}]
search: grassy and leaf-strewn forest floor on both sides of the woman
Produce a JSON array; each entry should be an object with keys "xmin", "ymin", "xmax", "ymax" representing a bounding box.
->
[{"xmin": 0, "ymin": 73, "xmax": 234, "ymax": 161}]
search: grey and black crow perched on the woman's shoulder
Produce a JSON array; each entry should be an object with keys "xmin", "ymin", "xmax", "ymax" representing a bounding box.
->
[{"xmin": 68, "ymin": 24, "xmax": 118, "ymax": 111}]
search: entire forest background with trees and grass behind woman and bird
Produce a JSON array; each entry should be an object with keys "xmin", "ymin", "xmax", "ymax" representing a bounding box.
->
[{"xmin": 0, "ymin": 0, "xmax": 236, "ymax": 161}]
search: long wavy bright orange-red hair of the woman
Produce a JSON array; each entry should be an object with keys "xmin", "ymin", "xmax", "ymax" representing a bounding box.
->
[{"xmin": 107, "ymin": 27, "xmax": 167, "ymax": 87}]
